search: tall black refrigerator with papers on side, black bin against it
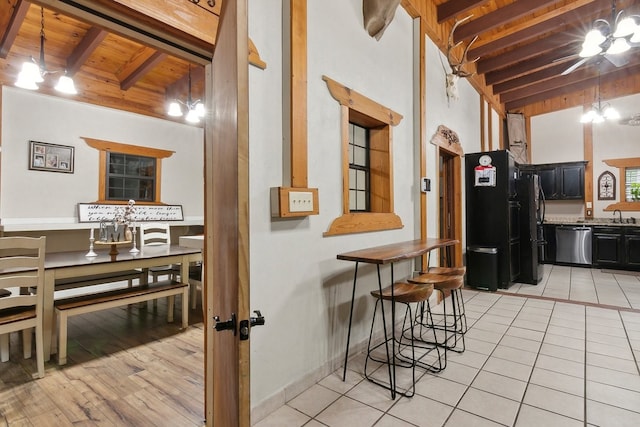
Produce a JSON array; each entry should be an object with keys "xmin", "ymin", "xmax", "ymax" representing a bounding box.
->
[{"xmin": 465, "ymin": 150, "xmax": 539, "ymax": 291}]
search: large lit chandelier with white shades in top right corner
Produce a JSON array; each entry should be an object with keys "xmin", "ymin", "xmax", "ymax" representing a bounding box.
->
[{"xmin": 579, "ymin": 0, "xmax": 640, "ymax": 58}]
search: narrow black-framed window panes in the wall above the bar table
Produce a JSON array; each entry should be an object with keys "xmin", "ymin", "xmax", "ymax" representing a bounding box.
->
[{"xmin": 349, "ymin": 123, "xmax": 371, "ymax": 212}]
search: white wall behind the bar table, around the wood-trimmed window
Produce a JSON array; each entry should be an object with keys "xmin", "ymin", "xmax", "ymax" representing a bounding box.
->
[{"xmin": 249, "ymin": 0, "xmax": 419, "ymax": 416}]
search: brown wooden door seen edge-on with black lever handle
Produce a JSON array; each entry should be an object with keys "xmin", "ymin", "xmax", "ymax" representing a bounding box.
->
[{"xmin": 204, "ymin": 0, "xmax": 251, "ymax": 427}]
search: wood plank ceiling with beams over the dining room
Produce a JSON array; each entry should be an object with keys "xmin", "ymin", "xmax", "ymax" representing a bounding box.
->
[{"xmin": 0, "ymin": 0, "xmax": 216, "ymax": 120}]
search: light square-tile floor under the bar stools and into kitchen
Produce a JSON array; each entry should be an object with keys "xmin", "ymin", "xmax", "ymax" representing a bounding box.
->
[{"xmin": 256, "ymin": 266, "xmax": 640, "ymax": 427}]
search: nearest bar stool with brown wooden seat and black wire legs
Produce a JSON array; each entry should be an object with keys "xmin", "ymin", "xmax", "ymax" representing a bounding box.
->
[{"xmin": 364, "ymin": 282, "xmax": 441, "ymax": 399}]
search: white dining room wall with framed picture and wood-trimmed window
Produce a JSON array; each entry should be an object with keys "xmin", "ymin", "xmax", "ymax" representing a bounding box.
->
[{"xmin": 0, "ymin": 86, "xmax": 204, "ymax": 231}]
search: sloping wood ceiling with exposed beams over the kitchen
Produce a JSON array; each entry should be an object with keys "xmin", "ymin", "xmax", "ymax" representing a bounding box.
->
[{"xmin": 434, "ymin": 0, "xmax": 640, "ymax": 115}]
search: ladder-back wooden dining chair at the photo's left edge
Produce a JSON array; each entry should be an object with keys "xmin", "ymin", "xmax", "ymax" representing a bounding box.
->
[{"xmin": 0, "ymin": 236, "xmax": 46, "ymax": 378}]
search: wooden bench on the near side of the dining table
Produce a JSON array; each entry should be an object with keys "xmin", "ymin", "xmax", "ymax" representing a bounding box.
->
[{"xmin": 55, "ymin": 280, "xmax": 189, "ymax": 365}]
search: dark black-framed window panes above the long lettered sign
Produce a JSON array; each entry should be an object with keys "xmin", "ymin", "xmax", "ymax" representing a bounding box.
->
[{"xmin": 106, "ymin": 152, "xmax": 157, "ymax": 202}]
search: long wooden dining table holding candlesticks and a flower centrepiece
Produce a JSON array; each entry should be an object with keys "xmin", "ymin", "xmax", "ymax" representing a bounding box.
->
[{"xmin": 43, "ymin": 245, "xmax": 202, "ymax": 360}]
